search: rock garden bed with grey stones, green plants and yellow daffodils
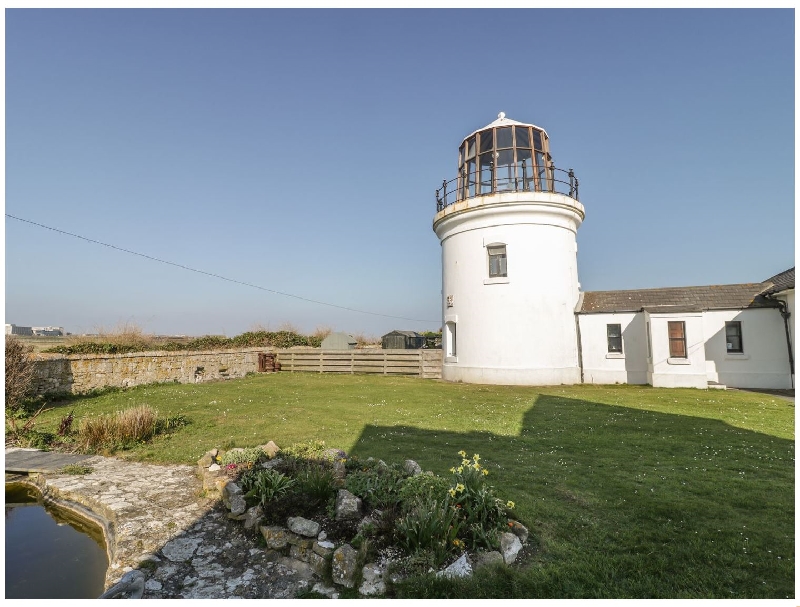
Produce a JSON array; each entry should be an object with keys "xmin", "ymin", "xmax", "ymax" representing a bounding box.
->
[{"xmin": 198, "ymin": 441, "xmax": 528, "ymax": 597}]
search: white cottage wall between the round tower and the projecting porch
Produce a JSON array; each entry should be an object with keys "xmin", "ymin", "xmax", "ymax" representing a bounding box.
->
[{"xmin": 577, "ymin": 312, "xmax": 647, "ymax": 384}]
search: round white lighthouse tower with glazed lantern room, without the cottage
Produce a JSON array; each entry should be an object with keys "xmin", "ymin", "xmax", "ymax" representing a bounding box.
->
[{"xmin": 433, "ymin": 112, "xmax": 584, "ymax": 385}]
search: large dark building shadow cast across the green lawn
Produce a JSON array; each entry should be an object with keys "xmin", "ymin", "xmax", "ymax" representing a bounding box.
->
[{"xmin": 352, "ymin": 395, "xmax": 794, "ymax": 598}]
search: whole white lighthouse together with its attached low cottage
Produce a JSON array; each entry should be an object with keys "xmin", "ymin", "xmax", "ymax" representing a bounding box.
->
[{"xmin": 433, "ymin": 113, "xmax": 794, "ymax": 389}]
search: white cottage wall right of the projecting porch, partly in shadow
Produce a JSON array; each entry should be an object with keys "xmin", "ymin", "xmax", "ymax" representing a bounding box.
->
[{"xmin": 703, "ymin": 308, "xmax": 792, "ymax": 389}]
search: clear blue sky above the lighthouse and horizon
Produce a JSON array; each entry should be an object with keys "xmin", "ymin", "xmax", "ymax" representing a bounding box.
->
[{"xmin": 5, "ymin": 9, "xmax": 795, "ymax": 336}]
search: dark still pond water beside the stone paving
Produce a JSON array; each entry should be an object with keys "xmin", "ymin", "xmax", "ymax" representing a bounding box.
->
[{"xmin": 5, "ymin": 484, "xmax": 108, "ymax": 599}]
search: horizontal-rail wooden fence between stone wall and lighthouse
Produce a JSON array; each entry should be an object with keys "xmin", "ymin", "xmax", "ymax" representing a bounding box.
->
[{"xmin": 277, "ymin": 348, "xmax": 442, "ymax": 379}]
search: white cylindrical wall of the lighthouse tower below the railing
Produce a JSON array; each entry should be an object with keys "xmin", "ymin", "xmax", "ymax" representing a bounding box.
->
[{"xmin": 434, "ymin": 192, "xmax": 583, "ymax": 385}]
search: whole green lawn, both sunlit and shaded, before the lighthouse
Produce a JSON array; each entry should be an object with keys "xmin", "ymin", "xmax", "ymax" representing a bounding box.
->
[{"xmin": 29, "ymin": 373, "xmax": 795, "ymax": 599}]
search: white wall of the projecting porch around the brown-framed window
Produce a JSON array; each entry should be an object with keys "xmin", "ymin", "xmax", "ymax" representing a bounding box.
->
[{"xmin": 644, "ymin": 311, "xmax": 708, "ymax": 389}]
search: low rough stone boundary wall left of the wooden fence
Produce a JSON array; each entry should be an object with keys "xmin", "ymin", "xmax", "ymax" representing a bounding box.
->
[{"xmin": 34, "ymin": 348, "xmax": 270, "ymax": 394}]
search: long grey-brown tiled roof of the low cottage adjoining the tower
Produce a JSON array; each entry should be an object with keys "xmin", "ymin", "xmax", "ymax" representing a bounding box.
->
[{"xmin": 578, "ymin": 282, "xmax": 777, "ymax": 314}]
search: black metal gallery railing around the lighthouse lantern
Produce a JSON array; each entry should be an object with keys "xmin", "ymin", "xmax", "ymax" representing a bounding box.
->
[{"xmin": 436, "ymin": 164, "xmax": 578, "ymax": 212}]
